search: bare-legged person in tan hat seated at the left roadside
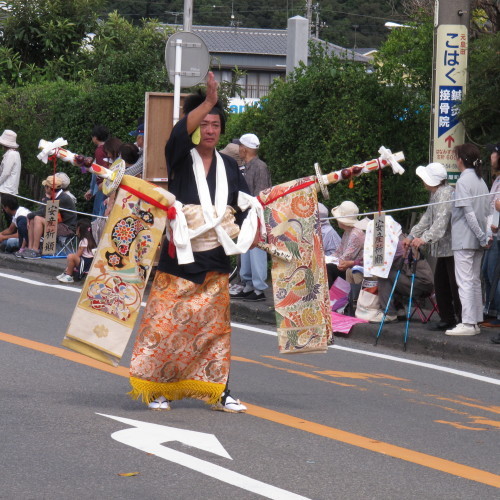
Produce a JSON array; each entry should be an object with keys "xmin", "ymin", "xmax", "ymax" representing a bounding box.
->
[{"xmin": 21, "ymin": 175, "xmax": 77, "ymax": 259}]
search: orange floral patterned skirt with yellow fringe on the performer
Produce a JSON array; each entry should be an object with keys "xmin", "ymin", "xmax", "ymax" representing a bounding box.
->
[{"xmin": 130, "ymin": 271, "xmax": 231, "ymax": 404}]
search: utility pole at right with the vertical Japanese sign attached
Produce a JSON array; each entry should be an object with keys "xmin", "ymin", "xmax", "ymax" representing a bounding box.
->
[{"xmin": 429, "ymin": 0, "xmax": 470, "ymax": 183}]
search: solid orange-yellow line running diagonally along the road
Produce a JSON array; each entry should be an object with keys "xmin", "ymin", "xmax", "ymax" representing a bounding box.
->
[{"xmin": 0, "ymin": 332, "xmax": 500, "ymax": 488}]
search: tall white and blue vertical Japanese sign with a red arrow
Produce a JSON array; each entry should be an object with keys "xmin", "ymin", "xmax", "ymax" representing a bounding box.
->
[{"xmin": 431, "ymin": 24, "xmax": 468, "ymax": 183}]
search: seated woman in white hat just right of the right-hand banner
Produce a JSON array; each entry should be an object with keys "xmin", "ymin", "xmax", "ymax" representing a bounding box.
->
[{"xmin": 326, "ymin": 201, "xmax": 368, "ymax": 288}]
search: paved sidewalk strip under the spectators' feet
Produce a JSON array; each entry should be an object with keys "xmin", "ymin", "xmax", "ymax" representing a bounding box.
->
[{"xmin": 0, "ymin": 253, "xmax": 500, "ymax": 371}]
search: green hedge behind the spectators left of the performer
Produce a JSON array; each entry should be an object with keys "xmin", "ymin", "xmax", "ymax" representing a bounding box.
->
[{"xmin": 0, "ymin": 82, "xmax": 151, "ymax": 211}]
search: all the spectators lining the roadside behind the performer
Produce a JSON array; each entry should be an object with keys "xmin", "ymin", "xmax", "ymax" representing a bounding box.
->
[{"xmin": 0, "ymin": 118, "xmax": 500, "ymax": 343}]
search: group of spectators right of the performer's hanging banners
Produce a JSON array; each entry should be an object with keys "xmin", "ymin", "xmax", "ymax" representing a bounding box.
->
[{"xmin": 320, "ymin": 143, "xmax": 500, "ymax": 343}]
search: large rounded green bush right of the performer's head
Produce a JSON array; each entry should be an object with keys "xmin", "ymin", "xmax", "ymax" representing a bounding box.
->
[{"xmin": 224, "ymin": 42, "xmax": 429, "ymax": 216}]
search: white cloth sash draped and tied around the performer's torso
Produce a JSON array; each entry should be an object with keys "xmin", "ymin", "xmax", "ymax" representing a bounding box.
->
[{"xmin": 170, "ymin": 148, "xmax": 266, "ymax": 264}]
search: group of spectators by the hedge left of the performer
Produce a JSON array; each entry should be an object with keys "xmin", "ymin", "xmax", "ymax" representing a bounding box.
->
[{"xmin": 0, "ymin": 117, "xmax": 144, "ymax": 282}]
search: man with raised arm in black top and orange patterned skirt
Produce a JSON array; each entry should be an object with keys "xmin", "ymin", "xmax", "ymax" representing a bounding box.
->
[{"xmin": 130, "ymin": 72, "xmax": 257, "ymax": 413}]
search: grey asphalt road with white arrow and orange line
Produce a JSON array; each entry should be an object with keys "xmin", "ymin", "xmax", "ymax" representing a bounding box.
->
[{"xmin": 0, "ymin": 269, "xmax": 500, "ymax": 500}]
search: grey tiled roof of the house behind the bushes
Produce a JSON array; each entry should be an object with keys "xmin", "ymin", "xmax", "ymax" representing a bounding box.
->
[{"xmin": 168, "ymin": 26, "xmax": 370, "ymax": 63}]
